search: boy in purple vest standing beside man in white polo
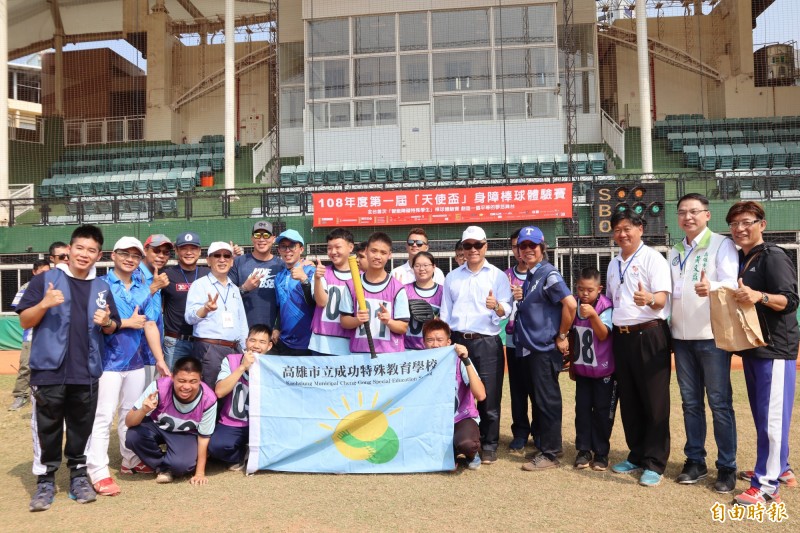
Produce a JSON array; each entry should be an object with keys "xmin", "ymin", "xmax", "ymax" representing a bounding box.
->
[{"xmin": 570, "ymin": 267, "xmax": 617, "ymax": 472}]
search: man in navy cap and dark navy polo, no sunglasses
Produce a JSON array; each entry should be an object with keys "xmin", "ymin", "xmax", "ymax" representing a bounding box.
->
[{"xmin": 161, "ymin": 231, "xmax": 210, "ymax": 368}]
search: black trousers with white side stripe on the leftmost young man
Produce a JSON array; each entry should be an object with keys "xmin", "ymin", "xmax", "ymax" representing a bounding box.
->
[{"xmin": 31, "ymin": 381, "xmax": 97, "ymax": 481}]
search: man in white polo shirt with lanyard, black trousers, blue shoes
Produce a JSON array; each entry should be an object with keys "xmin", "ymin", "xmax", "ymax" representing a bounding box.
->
[{"xmin": 606, "ymin": 209, "xmax": 672, "ymax": 487}]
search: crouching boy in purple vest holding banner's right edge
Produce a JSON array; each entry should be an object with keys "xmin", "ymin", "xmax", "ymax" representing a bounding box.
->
[{"xmin": 422, "ymin": 318, "xmax": 486, "ymax": 470}]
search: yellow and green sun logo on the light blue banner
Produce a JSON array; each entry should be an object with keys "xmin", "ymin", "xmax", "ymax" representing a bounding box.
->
[{"xmin": 320, "ymin": 391, "xmax": 402, "ymax": 464}]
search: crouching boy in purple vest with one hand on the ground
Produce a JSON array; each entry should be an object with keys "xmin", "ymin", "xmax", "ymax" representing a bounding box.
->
[{"xmin": 125, "ymin": 357, "xmax": 217, "ymax": 485}]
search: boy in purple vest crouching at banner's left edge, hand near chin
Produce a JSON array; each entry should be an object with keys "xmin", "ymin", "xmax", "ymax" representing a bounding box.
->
[{"xmin": 208, "ymin": 324, "xmax": 272, "ymax": 472}]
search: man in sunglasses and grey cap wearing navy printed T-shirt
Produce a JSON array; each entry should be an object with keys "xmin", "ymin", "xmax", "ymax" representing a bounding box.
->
[{"xmin": 228, "ymin": 220, "xmax": 284, "ymax": 327}]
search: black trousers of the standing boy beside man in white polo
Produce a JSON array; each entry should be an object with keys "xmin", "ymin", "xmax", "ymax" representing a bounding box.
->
[{"xmin": 575, "ymin": 376, "xmax": 617, "ymax": 457}]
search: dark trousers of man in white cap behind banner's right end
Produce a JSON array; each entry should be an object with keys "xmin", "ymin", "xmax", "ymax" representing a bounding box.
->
[{"xmin": 452, "ymin": 331, "xmax": 505, "ymax": 451}]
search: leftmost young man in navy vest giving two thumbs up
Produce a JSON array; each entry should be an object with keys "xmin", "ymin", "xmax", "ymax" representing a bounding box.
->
[{"xmin": 16, "ymin": 225, "xmax": 121, "ymax": 511}]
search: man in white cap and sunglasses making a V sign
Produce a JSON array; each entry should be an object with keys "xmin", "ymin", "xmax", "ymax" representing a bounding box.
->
[{"xmin": 184, "ymin": 241, "xmax": 248, "ymax": 389}]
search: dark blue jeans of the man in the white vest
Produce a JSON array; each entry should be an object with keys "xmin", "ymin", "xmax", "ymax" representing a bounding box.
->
[{"xmin": 672, "ymin": 339, "xmax": 736, "ymax": 470}]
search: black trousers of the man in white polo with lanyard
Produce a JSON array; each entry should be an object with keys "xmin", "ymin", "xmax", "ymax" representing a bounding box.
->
[{"xmin": 614, "ymin": 321, "xmax": 671, "ymax": 474}]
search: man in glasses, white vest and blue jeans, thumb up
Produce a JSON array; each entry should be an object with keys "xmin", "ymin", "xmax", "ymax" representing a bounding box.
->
[{"xmin": 669, "ymin": 193, "xmax": 739, "ymax": 493}]
